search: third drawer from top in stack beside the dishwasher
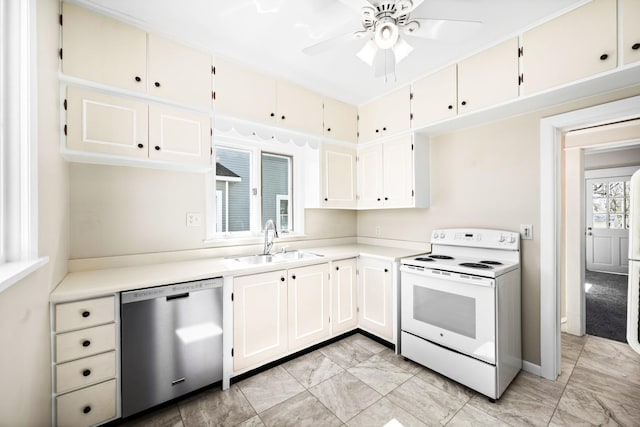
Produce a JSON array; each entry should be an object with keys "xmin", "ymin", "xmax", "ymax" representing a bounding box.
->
[{"xmin": 56, "ymin": 351, "xmax": 116, "ymax": 393}]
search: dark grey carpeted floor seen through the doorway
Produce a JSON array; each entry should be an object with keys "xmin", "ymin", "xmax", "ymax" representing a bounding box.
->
[{"xmin": 585, "ymin": 270, "xmax": 628, "ymax": 343}]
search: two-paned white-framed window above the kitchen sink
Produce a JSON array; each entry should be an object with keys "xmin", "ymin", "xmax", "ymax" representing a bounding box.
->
[{"xmin": 207, "ymin": 139, "xmax": 303, "ymax": 240}]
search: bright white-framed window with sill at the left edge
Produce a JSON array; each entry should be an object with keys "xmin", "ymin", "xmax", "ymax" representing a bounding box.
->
[{"xmin": 0, "ymin": 0, "xmax": 47, "ymax": 291}]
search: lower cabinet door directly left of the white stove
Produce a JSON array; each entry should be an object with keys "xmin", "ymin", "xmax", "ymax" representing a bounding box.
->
[{"xmin": 358, "ymin": 258, "xmax": 394, "ymax": 341}]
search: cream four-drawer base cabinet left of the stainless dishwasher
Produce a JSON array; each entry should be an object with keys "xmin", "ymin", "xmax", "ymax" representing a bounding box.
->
[{"xmin": 51, "ymin": 296, "xmax": 119, "ymax": 427}]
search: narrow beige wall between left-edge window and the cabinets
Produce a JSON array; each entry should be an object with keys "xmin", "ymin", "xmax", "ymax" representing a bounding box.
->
[{"xmin": 0, "ymin": 0, "xmax": 69, "ymax": 427}]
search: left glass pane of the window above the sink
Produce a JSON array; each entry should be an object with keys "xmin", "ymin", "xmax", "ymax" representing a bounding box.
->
[{"xmin": 216, "ymin": 147, "xmax": 251, "ymax": 233}]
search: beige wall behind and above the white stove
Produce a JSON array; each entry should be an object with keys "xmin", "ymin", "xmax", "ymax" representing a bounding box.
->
[{"xmin": 358, "ymin": 86, "xmax": 640, "ymax": 365}]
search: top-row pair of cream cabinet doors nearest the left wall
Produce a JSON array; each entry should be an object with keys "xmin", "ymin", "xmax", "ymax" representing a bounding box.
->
[{"xmin": 62, "ymin": 3, "xmax": 211, "ymax": 109}]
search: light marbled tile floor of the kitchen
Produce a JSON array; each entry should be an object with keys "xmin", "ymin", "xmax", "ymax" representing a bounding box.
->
[{"xmin": 119, "ymin": 334, "xmax": 640, "ymax": 427}]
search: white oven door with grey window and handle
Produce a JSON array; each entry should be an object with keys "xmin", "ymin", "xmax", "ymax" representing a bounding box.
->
[{"xmin": 400, "ymin": 265, "xmax": 496, "ymax": 364}]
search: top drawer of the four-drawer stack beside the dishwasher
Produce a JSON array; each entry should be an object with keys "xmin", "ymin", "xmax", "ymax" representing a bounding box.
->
[{"xmin": 56, "ymin": 296, "xmax": 115, "ymax": 332}]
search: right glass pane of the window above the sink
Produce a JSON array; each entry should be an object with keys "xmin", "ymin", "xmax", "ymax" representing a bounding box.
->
[{"xmin": 261, "ymin": 153, "xmax": 293, "ymax": 232}]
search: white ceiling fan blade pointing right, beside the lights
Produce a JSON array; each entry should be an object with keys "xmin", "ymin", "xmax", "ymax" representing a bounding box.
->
[{"xmin": 400, "ymin": 18, "xmax": 482, "ymax": 40}]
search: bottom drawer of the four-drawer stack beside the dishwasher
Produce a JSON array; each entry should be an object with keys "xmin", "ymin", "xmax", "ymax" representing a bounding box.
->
[{"xmin": 56, "ymin": 380, "xmax": 116, "ymax": 427}]
